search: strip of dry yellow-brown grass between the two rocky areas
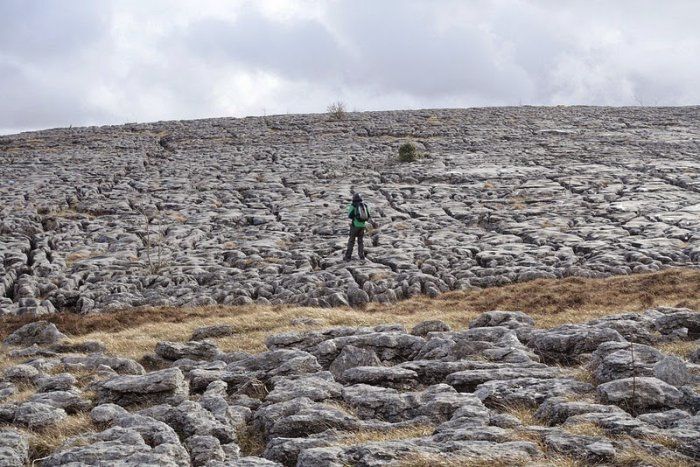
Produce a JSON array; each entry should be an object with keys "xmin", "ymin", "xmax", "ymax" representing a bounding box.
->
[{"xmin": 0, "ymin": 269, "xmax": 700, "ymax": 360}]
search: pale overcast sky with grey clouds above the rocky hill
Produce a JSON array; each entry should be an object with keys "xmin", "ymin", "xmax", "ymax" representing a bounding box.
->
[{"xmin": 0, "ymin": 0, "xmax": 700, "ymax": 133}]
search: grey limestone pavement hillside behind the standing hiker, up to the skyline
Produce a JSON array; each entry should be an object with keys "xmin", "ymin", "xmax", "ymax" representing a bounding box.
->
[{"xmin": 0, "ymin": 107, "xmax": 700, "ymax": 316}]
